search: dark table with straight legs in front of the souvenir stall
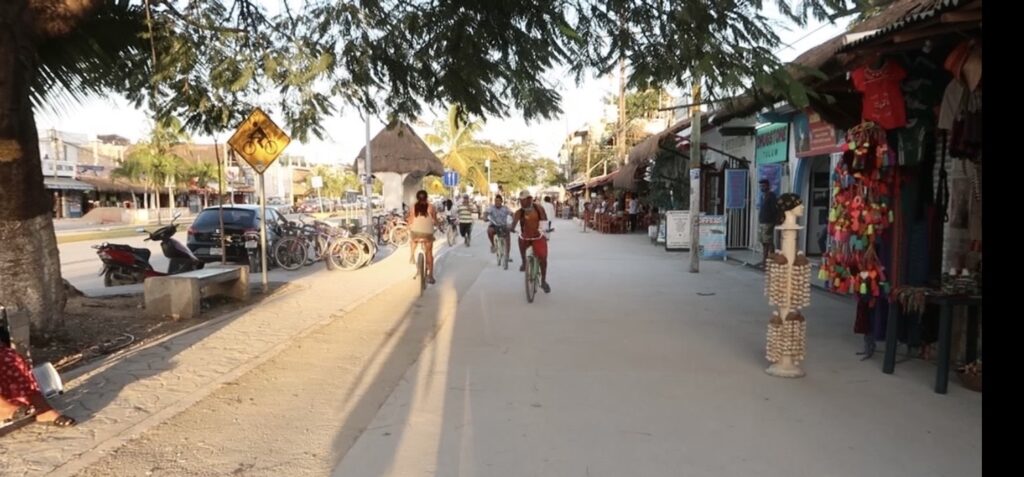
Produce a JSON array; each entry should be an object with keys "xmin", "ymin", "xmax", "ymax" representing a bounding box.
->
[{"xmin": 882, "ymin": 294, "xmax": 982, "ymax": 394}]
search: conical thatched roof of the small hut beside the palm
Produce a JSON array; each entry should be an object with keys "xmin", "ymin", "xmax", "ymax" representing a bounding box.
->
[{"xmin": 355, "ymin": 122, "xmax": 444, "ymax": 176}]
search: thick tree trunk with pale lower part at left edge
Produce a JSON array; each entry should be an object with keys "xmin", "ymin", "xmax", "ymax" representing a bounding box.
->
[{"xmin": 0, "ymin": 0, "xmax": 66, "ymax": 332}]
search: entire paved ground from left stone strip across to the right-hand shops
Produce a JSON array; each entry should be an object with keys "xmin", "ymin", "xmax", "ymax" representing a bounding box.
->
[{"xmin": 0, "ymin": 218, "xmax": 981, "ymax": 477}]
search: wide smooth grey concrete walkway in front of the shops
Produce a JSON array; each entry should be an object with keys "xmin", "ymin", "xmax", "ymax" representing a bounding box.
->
[{"xmin": 334, "ymin": 223, "xmax": 981, "ymax": 477}]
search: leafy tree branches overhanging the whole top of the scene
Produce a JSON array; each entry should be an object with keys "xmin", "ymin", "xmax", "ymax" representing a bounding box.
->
[{"xmin": 33, "ymin": 0, "xmax": 856, "ymax": 140}]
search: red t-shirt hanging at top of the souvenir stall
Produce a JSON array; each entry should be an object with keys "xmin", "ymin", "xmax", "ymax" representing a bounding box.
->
[{"xmin": 851, "ymin": 60, "xmax": 906, "ymax": 130}]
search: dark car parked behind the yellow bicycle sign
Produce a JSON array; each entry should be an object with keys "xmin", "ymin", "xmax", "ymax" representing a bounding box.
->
[{"xmin": 187, "ymin": 205, "xmax": 286, "ymax": 263}]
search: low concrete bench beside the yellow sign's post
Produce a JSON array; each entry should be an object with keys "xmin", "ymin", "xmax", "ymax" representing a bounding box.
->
[{"xmin": 144, "ymin": 265, "xmax": 249, "ymax": 319}]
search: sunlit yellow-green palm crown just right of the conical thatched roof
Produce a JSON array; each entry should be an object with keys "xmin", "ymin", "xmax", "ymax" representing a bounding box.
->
[{"xmin": 424, "ymin": 104, "xmax": 491, "ymax": 190}]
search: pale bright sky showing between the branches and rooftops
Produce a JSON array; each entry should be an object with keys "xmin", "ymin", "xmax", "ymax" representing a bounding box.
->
[{"xmin": 36, "ymin": 0, "xmax": 849, "ymax": 164}]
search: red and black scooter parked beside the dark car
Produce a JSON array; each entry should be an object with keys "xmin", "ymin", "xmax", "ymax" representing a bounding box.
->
[{"xmin": 92, "ymin": 210, "xmax": 203, "ymax": 287}]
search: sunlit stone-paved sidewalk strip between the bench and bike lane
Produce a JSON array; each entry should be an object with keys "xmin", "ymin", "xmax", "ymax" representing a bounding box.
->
[{"xmin": 0, "ymin": 243, "xmax": 450, "ymax": 476}]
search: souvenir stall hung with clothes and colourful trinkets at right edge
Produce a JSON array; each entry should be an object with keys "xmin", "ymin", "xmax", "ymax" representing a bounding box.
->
[{"xmin": 817, "ymin": 15, "xmax": 982, "ymax": 393}]
